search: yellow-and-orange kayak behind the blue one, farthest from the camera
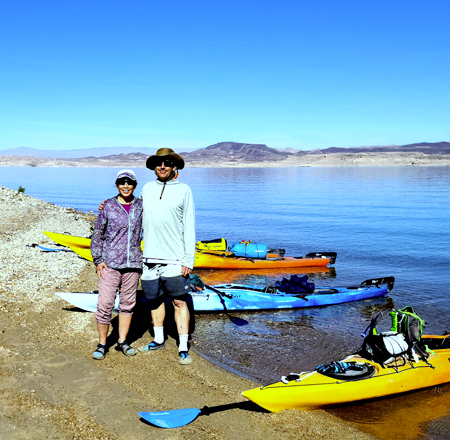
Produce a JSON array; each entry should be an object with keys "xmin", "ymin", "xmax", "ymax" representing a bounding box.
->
[{"xmin": 43, "ymin": 231, "xmax": 337, "ymax": 270}]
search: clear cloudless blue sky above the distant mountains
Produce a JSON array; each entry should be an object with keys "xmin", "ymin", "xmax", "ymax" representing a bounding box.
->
[{"xmin": 0, "ymin": 0, "xmax": 450, "ymax": 151}]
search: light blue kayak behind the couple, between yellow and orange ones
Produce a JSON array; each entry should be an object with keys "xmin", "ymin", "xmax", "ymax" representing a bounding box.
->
[{"xmin": 56, "ymin": 277, "xmax": 395, "ymax": 313}]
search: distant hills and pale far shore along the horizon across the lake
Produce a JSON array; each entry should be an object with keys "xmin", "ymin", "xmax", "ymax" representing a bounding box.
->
[{"xmin": 0, "ymin": 142, "xmax": 450, "ymax": 167}]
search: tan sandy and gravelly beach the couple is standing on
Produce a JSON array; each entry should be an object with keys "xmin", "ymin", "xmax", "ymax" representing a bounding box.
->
[{"xmin": 0, "ymin": 187, "xmax": 374, "ymax": 440}]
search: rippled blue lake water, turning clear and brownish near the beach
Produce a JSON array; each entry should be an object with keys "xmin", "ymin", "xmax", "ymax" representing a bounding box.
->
[{"xmin": 0, "ymin": 167, "xmax": 450, "ymax": 440}]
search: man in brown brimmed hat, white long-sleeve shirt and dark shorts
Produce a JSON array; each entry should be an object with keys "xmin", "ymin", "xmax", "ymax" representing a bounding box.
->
[{"xmin": 139, "ymin": 148, "xmax": 195, "ymax": 365}]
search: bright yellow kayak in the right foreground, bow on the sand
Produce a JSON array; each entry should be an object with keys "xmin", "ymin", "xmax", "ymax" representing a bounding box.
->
[{"xmin": 242, "ymin": 336, "xmax": 450, "ymax": 412}]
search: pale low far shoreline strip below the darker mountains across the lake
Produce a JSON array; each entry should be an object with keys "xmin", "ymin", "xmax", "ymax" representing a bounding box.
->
[{"xmin": 0, "ymin": 152, "xmax": 450, "ymax": 168}]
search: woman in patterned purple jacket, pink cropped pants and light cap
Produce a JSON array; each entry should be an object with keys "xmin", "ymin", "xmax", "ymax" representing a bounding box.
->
[{"xmin": 91, "ymin": 170, "xmax": 142, "ymax": 360}]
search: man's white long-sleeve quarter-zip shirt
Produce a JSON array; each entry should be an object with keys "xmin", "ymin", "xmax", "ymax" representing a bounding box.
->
[{"xmin": 141, "ymin": 179, "xmax": 196, "ymax": 269}]
